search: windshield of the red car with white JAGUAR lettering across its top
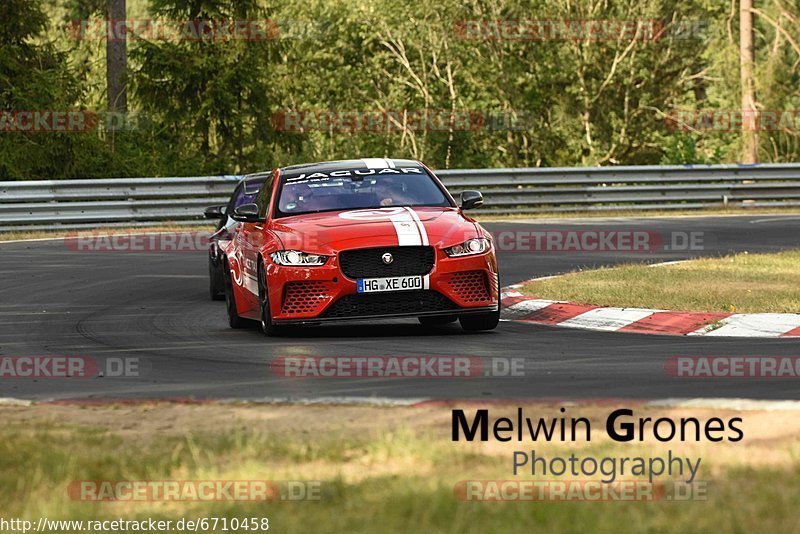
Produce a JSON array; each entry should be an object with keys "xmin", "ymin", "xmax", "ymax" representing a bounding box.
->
[{"xmin": 277, "ymin": 168, "xmax": 452, "ymax": 216}]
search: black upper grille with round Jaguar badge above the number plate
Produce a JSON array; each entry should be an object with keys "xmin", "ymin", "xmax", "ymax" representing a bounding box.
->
[{"xmin": 339, "ymin": 247, "xmax": 436, "ymax": 279}]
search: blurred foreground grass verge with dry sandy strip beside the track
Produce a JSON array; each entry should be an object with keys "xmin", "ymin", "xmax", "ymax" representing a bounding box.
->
[{"xmin": 0, "ymin": 404, "xmax": 800, "ymax": 533}]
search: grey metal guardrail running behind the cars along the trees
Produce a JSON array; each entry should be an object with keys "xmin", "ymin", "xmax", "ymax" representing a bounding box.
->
[{"xmin": 0, "ymin": 163, "xmax": 800, "ymax": 232}]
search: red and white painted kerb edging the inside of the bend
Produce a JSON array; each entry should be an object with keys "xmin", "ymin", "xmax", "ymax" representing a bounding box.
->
[{"xmin": 500, "ymin": 284, "xmax": 800, "ymax": 338}]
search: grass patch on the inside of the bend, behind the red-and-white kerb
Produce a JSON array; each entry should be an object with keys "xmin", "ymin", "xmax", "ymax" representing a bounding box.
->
[{"xmin": 520, "ymin": 250, "xmax": 800, "ymax": 313}]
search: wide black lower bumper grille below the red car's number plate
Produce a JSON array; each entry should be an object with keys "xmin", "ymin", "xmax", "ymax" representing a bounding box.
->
[{"xmin": 323, "ymin": 290, "xmax": 458, "ymax": 318}]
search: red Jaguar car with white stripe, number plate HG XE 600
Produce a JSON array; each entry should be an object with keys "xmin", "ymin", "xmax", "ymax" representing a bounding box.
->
[{"xmin": 223, "ymin": 158, "xmax": 500, "ymax": 335}]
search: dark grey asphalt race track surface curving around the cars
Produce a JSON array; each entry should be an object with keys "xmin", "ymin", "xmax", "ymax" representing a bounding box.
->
[{"xmin": 0, "ymin": 215, "xmax": 800, "ymax": 400}]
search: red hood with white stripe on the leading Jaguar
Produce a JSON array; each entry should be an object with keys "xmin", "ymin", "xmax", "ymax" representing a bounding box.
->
[{"xmin": 271, "ymin": 207, "xmax": 480, "ymax": 253}]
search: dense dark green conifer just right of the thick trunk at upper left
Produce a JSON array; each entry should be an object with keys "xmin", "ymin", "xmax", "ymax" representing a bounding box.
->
[{"xmin": 131, "ymin": 0, "xmax": 276, "ymax": 173}]
